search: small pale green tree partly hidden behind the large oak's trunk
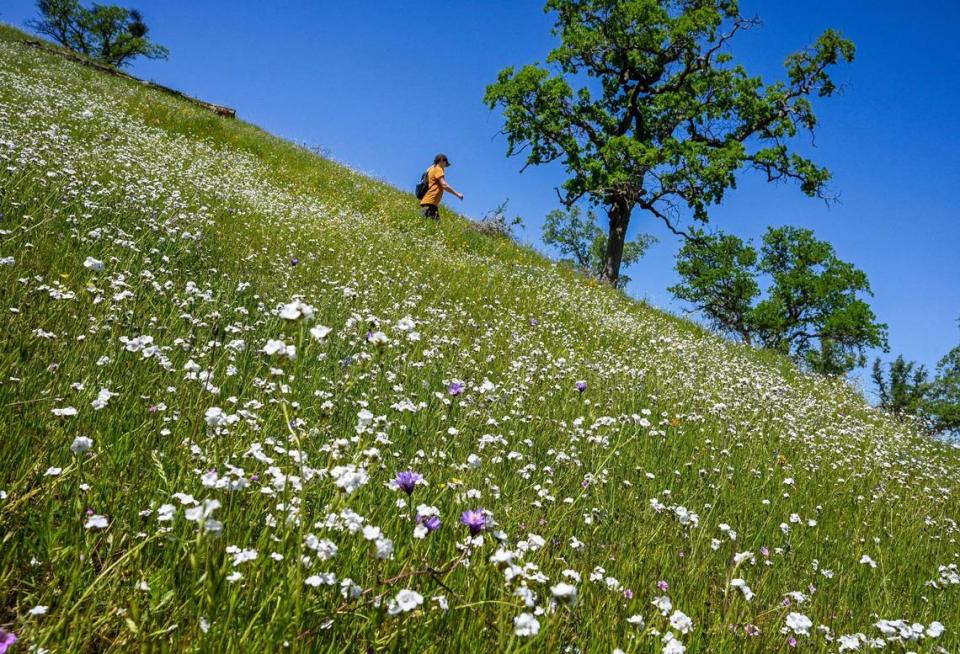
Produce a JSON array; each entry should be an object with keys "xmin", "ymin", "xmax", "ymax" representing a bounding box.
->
[{"xmin": 543, "ymin": 205, "xmax": 657, "ymax": 288}]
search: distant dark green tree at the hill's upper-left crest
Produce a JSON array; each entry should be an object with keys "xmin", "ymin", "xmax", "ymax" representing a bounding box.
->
[{"xmin": 27, "ymin": 0, "xmax": 169, "ymax": 67}]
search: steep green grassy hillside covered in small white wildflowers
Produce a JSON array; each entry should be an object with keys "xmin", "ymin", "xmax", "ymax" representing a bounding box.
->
[{"xmin": 0, "ymin": 23, "xmax": 960, "ymax": 652}]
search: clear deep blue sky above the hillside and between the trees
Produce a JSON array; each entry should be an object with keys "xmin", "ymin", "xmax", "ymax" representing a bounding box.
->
[{"xmin": 0, "ymin": 0, "xmax": 960, "ymax": 384}]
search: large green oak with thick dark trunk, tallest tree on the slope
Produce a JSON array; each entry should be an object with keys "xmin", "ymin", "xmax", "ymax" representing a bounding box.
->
[{"xmin": 484, "ymin": 0, "xmax": 854, "ymax": 284}]
